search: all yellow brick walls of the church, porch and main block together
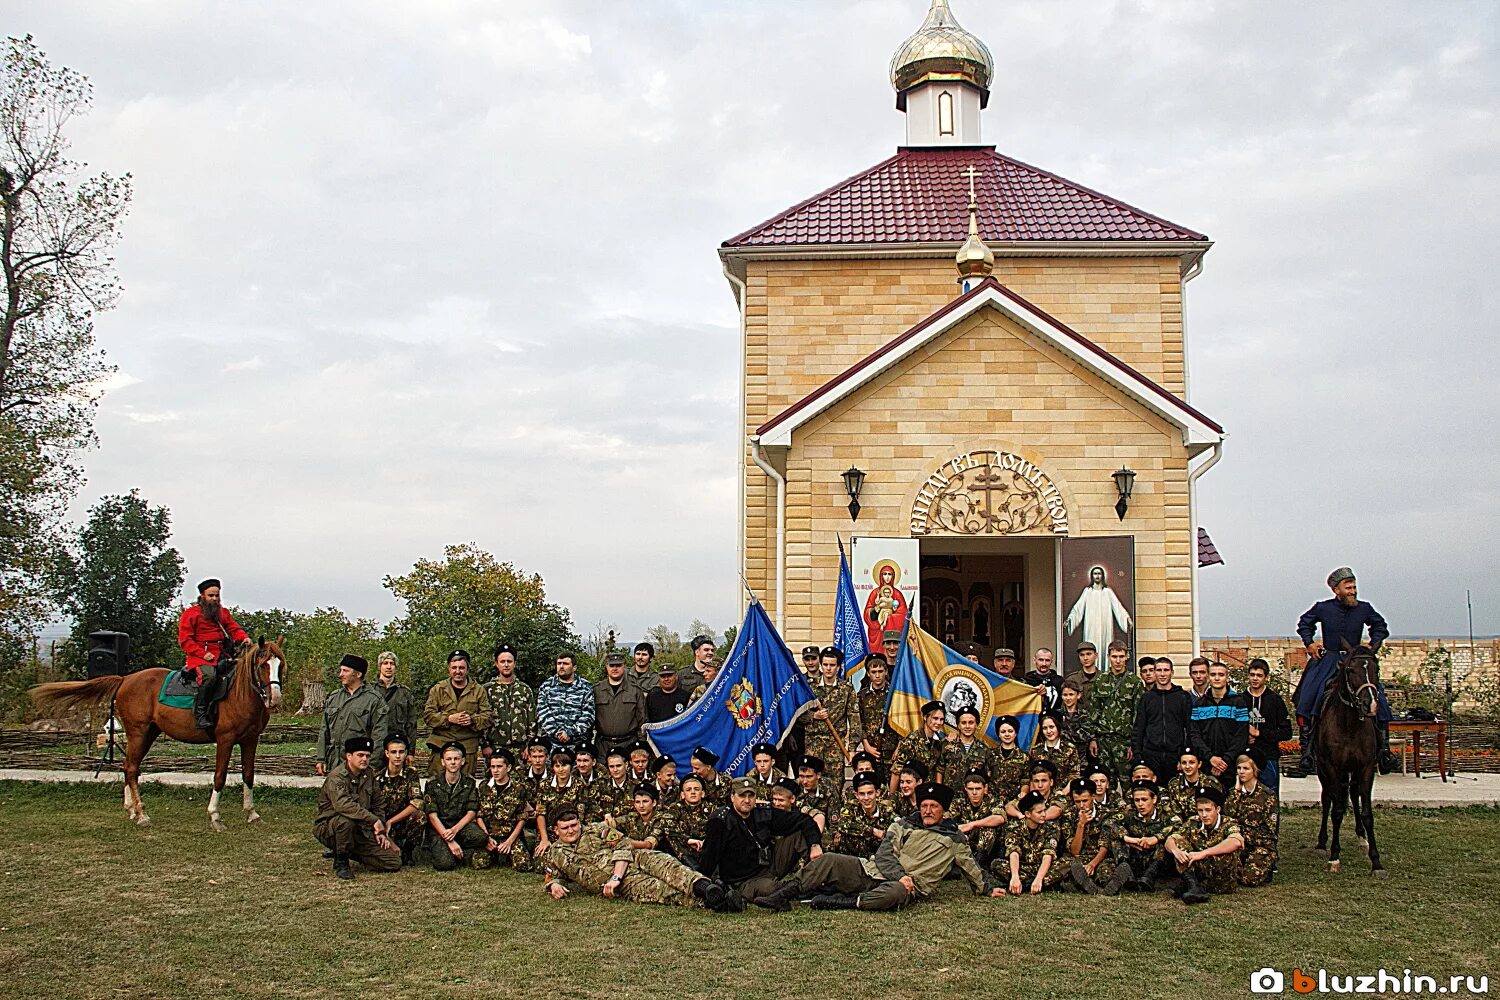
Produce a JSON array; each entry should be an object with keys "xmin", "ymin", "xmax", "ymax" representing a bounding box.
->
[{"xmin": 743, "ymin": 256, "xmax": 1196, "ymax": 663}]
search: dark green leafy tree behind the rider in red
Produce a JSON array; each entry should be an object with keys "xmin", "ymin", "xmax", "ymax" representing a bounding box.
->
[{"xmin": 51, "ymin": 490, "xmax": 183, "ymax": 672}]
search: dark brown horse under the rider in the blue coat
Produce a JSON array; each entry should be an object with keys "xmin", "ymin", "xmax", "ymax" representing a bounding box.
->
[{"xmin": 1314, "ymin": 643, "xmax": 1386, "ymax": 877}]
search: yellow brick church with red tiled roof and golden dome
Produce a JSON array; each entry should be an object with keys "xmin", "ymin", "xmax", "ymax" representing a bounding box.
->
[{"xmin": 719, "ymin": 0, "xmax": 1224, "ymax": 669}]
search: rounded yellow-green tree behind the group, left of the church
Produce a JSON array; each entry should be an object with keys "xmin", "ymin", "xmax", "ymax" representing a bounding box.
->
[{"xmin": 384, "ymin": 544, "xmax": 582, "ymax": 688}]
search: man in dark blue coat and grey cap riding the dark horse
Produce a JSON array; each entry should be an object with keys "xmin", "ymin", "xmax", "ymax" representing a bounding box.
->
[{"xmin": 1293, "ymin": 567, "xmax": 1397, "ymax": 774}]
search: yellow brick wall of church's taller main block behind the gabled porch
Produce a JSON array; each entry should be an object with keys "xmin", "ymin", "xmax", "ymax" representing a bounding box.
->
[{"xmin": 744, "ymin": 256, "xmax": 1187, "ymax": 628}]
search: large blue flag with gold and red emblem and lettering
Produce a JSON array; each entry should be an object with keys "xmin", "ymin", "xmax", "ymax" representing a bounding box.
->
[{"xmin": 645, "ymin": 600, "xmax": 818, "ymax": 778}]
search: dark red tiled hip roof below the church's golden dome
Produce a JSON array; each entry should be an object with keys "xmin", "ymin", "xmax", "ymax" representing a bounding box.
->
[{"xmin": 725, "ymin": 145, "xmax": 1208, "ymax": 247}]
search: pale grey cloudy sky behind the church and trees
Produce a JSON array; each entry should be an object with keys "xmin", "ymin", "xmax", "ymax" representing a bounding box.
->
[{"xmin": 6, "ymin": 0, "xmax": 1500, "ymax": 636}]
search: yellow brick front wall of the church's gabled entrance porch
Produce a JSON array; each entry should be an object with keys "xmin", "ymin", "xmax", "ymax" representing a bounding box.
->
[{"xmin": 752, "ymin": 312, "xmax": 1193, "ymax": 657}]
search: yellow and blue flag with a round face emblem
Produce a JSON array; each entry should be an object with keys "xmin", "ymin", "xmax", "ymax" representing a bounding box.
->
[{"xmin": 887, "ymin": 619, "xmax": 1041, "ymax": 750}]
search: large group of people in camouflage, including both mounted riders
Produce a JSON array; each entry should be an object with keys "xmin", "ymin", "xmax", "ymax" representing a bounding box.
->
[{"xmin": 185, "ymin": 568, "xmax": 1386, "ymax": 912}]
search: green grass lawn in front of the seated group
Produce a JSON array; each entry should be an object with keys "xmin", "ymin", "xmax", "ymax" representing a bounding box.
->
[{"xmin": 0, "ymin": 783, "xmax": 1500, "ymax": 1000}]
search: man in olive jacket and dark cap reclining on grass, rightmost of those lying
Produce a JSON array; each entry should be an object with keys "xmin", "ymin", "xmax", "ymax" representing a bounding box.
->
[{"xmin": 759, "ymin": 783, "xmax": 1004, "ymax": 910}]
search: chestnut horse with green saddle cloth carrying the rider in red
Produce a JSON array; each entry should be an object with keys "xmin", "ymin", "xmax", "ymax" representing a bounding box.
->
[{"xmin": 32, "ymin": 637, "xmax": 284, "ymax": 832}]
